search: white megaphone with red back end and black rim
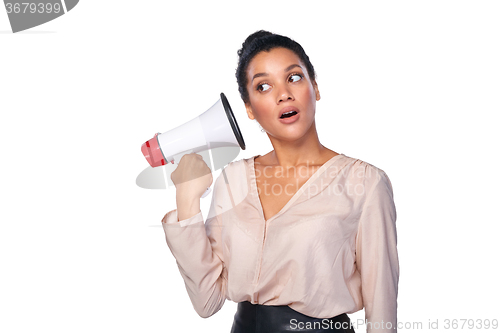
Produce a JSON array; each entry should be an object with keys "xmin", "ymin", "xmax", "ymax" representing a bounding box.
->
[{"xmin": 141, "ymin": 93, "xmax": 245, "ymax": 197}]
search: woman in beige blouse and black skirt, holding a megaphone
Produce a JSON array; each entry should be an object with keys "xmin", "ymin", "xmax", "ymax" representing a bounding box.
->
[{"xmin": 162, "ymin": 31, "xmax": 399, "ymax": 333}]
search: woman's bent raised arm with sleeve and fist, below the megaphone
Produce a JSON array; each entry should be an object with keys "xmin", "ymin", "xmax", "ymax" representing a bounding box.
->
[{"xmin": 162, "ymin": 154, "xmax": 227, "ymax": 318}]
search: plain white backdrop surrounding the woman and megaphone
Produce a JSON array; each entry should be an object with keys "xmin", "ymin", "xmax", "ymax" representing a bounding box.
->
[{"xmin": 0, "ymin": 0, "xmax": 500, "ymax": 333}]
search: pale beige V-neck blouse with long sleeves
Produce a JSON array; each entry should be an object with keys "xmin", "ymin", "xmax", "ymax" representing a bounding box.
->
[{"xmin": 162, "ymin": 154, "xmax": 399, "ymax": 332}]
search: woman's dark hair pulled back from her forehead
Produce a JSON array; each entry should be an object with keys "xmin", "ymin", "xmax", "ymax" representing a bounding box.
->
[{"xmin": 236, "ymin": 30, "xmax": 316, "ymax": 104}]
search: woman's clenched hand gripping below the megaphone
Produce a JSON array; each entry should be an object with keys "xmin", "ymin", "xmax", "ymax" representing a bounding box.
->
[{"xmin": 170, "ymin": 153, "xmax": 213, "ymax": 199}]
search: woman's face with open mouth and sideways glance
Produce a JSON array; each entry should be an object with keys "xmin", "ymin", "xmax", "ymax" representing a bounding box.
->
[{"xmin": 246, "ymin": 47, "xmax": 320, "ymax": 141}]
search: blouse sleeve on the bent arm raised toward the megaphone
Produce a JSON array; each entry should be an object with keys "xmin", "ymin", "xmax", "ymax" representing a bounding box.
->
[{"xmin": 162, "ymin": 177, "xmax": 227, "ymax": 318}]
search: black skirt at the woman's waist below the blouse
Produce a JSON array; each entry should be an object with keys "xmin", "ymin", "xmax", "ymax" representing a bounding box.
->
[{"xmin": 231, "ymin": 301, "xmax": 354, "ymax": 333}]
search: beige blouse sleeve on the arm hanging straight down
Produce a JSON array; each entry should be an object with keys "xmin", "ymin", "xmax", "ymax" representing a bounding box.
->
[{"xmin": 356, "ymin": 167, "xmax": 399, "ymax": 333}]
